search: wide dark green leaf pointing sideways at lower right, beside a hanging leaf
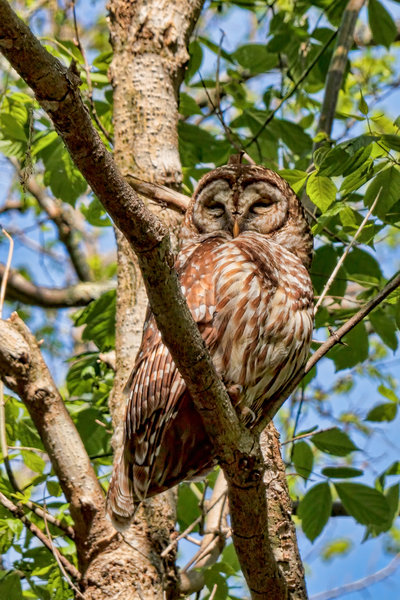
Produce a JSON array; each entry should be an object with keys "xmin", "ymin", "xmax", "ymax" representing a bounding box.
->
[{"xmin": 335, "ymin": 482, "xmax": 390, "ymax": 525}]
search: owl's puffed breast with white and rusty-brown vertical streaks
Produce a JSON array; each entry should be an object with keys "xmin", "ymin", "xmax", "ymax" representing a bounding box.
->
[{"xmin": 184, "ymin": 232, "xmax": 313, "ymax": 422}]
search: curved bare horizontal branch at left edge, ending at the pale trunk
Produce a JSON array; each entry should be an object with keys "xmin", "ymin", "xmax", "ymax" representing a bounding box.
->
[{"xmin": 0, "ymin": 263, "xmax": 115, "ymax": 308}]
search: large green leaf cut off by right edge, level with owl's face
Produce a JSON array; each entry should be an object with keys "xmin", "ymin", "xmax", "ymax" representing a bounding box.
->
[{"xmin": 364, "ymin": 165, "xmax": 400, "ymax": 220}]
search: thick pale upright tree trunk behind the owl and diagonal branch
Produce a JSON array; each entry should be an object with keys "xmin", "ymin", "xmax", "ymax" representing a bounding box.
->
[{"xmin": 103, "ymin": 0, "xmax": 202, "ymax": 599}]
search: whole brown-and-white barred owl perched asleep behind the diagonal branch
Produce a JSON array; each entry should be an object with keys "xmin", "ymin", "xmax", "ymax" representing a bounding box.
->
[{"xmin": 107, "ymin": 164, "xmax": 313, "ymax": 529}]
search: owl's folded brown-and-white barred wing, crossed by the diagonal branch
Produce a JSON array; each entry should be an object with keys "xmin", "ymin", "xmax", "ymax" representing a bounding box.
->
[{"xmin": 108, "ymin": 238, "xmax": 221, "ymax": 525}]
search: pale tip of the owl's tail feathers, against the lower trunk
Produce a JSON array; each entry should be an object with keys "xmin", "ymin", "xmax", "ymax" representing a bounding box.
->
[{"xmin": 106, "ymin": 448, "xmax": 140, "ymax": 532}]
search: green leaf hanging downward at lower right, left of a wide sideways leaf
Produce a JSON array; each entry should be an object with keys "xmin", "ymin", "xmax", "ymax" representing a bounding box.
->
[{"xmin": 297, "ymin": 482, "xmax": 332, "ymax": 542}]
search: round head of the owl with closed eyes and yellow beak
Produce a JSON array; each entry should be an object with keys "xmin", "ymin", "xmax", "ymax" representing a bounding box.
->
[{"xmin": 180, "ymin": 164, "xmax": 312, "ymax": 268}]
